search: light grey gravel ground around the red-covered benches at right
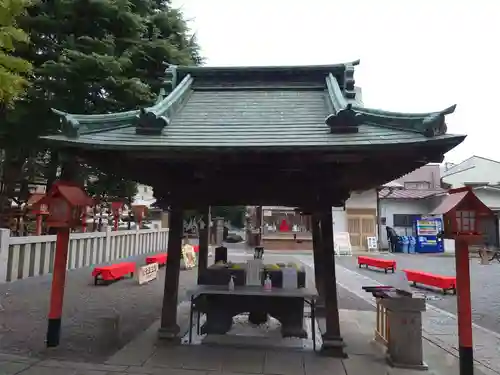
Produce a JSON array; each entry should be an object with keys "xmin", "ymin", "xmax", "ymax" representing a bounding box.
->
[{"xmin": 336, "ymin": 254, "xmax": 500, "ymax": 333}]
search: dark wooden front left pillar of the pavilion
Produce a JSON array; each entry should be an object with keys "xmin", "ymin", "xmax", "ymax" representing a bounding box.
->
[{"xmin": 158, "ymin": 205, "xmax": 183, "ymax": 342}]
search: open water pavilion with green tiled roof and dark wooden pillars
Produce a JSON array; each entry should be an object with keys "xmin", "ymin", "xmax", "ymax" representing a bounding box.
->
[{"xmin": 44, "ymin": 61, "xmax": 465, "ymax": 356}]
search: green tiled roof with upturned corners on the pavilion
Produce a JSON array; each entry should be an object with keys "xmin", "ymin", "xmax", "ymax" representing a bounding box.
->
[{"xmin": 44, "ymin": 62, "xmax": 463, "ymax": 151}]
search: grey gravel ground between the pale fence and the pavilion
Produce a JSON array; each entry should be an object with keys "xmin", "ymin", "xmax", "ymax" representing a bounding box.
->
[{"xmin": 0, "ymin": 255, "xmax": 201, "ymax": 361}]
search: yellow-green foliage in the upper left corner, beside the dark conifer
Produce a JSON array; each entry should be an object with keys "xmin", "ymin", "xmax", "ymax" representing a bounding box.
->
[{"xmin": 0, "ymin": 0, "xmax": 32, "ymax": 106}]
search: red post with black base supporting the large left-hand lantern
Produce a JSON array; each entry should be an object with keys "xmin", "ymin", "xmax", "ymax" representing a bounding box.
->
[{"xmin": 47, "ymin": 228, "xmax": 70, "ymax": 348}]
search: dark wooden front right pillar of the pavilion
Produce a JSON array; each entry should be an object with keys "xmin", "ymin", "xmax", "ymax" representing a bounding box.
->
[{"xmin": 321, "ymin": 206, "xmax": 346, "ymax": 358}]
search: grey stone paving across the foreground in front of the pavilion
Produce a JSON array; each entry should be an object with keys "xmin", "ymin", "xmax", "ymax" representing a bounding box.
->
[{"xmin": 0, "ymin": 310, "xmax": 490, "ymax": 375}]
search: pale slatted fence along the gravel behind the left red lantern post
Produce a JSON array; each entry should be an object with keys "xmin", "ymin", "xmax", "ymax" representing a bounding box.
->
[{"xmin": 0, "ymin": 229, "xmax": 168, "ymax": 283}]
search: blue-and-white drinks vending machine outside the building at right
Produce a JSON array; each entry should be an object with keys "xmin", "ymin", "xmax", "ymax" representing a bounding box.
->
[{"xmin": 415, "ymin": 216, "xmax": 444, "ymax": 253}]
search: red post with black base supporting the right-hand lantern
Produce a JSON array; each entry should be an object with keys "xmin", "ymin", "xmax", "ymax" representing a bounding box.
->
[{"xmin": 455, "ymin": 235, "xmax": 474, "ymax": 375}]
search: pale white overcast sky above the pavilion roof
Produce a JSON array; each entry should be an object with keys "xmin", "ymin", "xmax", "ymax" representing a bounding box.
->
[{"xmin": 173, "ymin": 0, "xmax": 500, "ymax": 162}]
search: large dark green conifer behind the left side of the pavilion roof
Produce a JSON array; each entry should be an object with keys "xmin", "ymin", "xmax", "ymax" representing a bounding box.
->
[{"xmin": 0, "ymin": 0, "xmax": 201, "ymax": 225}]
